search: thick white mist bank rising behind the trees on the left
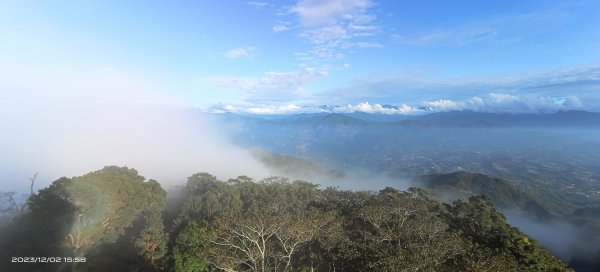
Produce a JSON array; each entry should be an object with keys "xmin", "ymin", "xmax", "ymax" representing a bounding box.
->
[{"xmin": 0, "ymin": 67, "xmax": 270, "ymax": 192}]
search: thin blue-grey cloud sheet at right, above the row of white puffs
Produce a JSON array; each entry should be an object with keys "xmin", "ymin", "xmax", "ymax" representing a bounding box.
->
[{"xmin": 315, "ymin": 65, "xmax": 600, "ymax": 105}]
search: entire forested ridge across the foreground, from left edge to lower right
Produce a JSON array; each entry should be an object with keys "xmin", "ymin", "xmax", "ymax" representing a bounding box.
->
[{"xmin": 0, "ymin": 166, "xmax": 570, "ymax": 271}]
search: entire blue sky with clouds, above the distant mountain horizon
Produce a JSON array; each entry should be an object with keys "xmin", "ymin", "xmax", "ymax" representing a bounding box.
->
[{"xmin": 0, "ymin": 0, "xmax": 600, "ymax": 114}]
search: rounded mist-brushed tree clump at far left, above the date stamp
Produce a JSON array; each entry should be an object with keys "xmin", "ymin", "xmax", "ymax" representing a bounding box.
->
[{"xmin": 0, "ymin": 166, "xmax": 167, "ymax": 271}]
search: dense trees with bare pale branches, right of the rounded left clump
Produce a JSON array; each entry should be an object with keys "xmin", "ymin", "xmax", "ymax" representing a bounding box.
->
[{"xmin": 173, "ymin": 173, "xmax": 568, "ymax": 271}]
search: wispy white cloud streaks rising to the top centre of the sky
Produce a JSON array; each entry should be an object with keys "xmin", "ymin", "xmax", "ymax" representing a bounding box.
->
[{"xmin": 213, "ymin": 0, "xmax": 383, "ymax": 107}]
